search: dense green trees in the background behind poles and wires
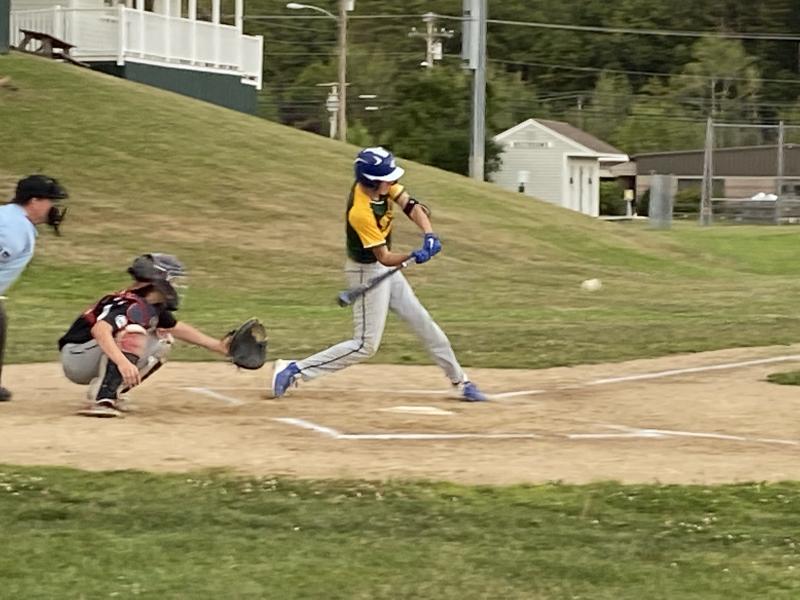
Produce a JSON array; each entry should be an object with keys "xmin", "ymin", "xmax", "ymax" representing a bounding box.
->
[{"xmin": 239, "ymin": 0, "xmax": 800, "ymax": 172}]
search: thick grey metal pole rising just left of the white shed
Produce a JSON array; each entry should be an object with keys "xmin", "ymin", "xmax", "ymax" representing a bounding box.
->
[{"xmin": 461, "ymin": 0, "xmax": 488, "ymax": 181}]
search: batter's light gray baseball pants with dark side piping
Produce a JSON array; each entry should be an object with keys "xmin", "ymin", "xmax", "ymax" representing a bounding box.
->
[{"xmin": 297, "ymin": 260, "xmax": 466, "ymax": 384}]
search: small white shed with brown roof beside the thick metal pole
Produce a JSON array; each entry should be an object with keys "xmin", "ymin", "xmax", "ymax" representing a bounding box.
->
[{"xmin": 491, "ymin": 119, "xmax": 628, "ymax": 217}]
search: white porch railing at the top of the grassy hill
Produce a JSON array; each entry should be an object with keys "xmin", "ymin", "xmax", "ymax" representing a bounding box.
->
[{"xmin": 11, "ymin": 4, "xmax": 263, "ymax": 89}]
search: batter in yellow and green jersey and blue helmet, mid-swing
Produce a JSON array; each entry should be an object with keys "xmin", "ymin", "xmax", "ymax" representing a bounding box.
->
[{"xmin": 272, "ymin": 147, "xmax": 487, "ymax": 402}]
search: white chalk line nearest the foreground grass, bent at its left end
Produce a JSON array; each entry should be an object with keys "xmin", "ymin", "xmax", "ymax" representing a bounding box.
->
[{"xmin": 273, "ymin": 417, "xmax": 800, "ymax": 446}]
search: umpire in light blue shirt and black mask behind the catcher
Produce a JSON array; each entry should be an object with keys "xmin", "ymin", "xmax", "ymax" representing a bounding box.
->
[{"xmin": 0, "ymin": 175, "xmax": 67, "ymax": 402}]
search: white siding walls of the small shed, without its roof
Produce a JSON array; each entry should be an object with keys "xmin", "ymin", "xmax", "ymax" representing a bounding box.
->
[{"xmin": 492, "ymin": 127, "xmax": 575, "ymax": 204}]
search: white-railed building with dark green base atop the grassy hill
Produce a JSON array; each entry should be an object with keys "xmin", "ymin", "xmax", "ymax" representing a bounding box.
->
[{"xmin": 7, "ymin": 0, "xmax": 263, "ymax": 113}]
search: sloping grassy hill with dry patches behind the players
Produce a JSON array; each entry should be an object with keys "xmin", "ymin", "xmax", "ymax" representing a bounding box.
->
[{"xmin": 0, "ymin": 54, "xmax": 800, "ymax": 367}]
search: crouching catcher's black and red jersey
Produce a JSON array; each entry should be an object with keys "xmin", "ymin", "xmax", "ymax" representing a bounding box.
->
[{"xmin": 58, "ymin": 287, "xmax": 178, "ymax": 350}]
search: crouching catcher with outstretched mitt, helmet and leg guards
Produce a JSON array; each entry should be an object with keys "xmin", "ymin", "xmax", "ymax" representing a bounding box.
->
[{"xmin": 58, "ymin": 253, "xmax": 267, "ymax": 417}]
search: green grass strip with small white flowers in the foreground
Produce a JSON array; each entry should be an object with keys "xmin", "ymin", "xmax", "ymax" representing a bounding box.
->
[{"xmin": 0, "ymin": 467, "xmax": 800, "ymax": 600}]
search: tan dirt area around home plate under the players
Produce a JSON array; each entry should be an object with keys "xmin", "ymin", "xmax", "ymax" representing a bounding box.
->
[{"xmin": 0, "ymin": 346, "xmax": 800, "ymax": 484}]
